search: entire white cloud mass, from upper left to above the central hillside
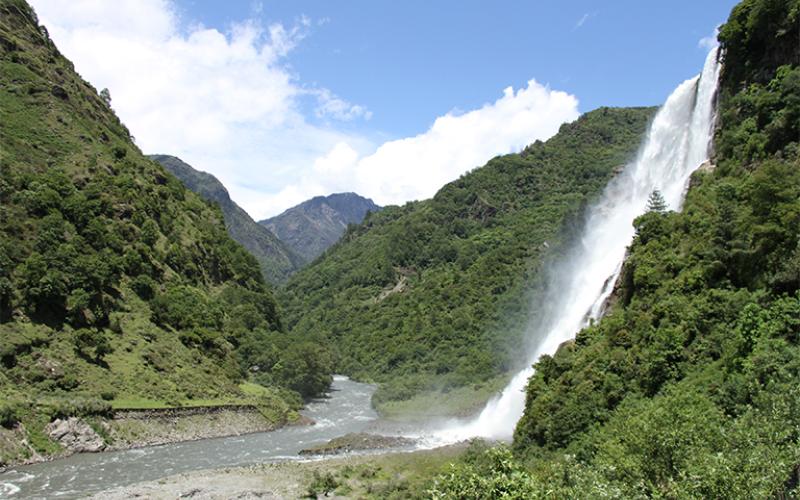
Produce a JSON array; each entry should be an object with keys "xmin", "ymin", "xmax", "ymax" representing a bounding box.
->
[{"xmin": 33, "ymin": 0, "xmax": 578, "ymax": 219}]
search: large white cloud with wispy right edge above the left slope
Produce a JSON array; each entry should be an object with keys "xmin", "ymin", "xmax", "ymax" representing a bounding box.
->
[{"xmin": 28, "ymin": 0, "xmax": 369, "ymax": 216}]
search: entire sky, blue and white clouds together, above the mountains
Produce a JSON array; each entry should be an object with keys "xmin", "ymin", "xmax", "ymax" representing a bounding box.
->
[{"xmin": 31, "ymin": 0, "xmax": 736, "ymax": 220}]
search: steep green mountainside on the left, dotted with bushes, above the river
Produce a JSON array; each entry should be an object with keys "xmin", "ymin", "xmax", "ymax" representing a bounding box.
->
[{"xmin": 0, "ymin": 0, "xmax": 331, "ymax": 461}]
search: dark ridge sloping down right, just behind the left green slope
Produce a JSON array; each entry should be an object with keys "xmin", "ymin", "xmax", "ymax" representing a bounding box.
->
[{"xmin": 149, "ymin": 155, "xmax": 303, "ymax": 284}]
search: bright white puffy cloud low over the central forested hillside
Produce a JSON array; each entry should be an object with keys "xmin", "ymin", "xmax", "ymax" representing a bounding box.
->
[{"xmin": 247, "ymin": 80, "xmax": 579, "ymax": 215}]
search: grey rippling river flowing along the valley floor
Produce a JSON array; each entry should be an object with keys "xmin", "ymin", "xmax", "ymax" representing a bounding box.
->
[{"xmin": 0, "ymin": 376, "xmax": 378, "ymax": 498}]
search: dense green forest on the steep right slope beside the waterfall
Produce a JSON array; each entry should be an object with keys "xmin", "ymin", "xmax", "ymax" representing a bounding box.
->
[{"xmin": 431, "ymin": 0, "xmax": 800, "ymax": 498}]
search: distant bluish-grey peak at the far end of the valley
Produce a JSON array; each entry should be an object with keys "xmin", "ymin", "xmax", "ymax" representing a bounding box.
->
[{"xmin": 259, "ymin": 193, "xmax": 380, "ymax": 262}]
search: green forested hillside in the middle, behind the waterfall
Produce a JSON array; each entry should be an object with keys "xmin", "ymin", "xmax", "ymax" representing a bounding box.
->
[{"xmin": 281, "ymin": 108, "xmax": 654, "ymax": 410}]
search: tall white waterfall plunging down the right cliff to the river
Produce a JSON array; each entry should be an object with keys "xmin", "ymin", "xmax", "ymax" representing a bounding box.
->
[{"xmin": 436, "ymin": 49, "xmax": 719, "ymax": 441}]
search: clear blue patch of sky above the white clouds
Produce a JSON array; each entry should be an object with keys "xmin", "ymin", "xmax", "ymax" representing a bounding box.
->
[{"xmin": 179, "ymin": 0, "xmax": 737, "ymax": 137}]
